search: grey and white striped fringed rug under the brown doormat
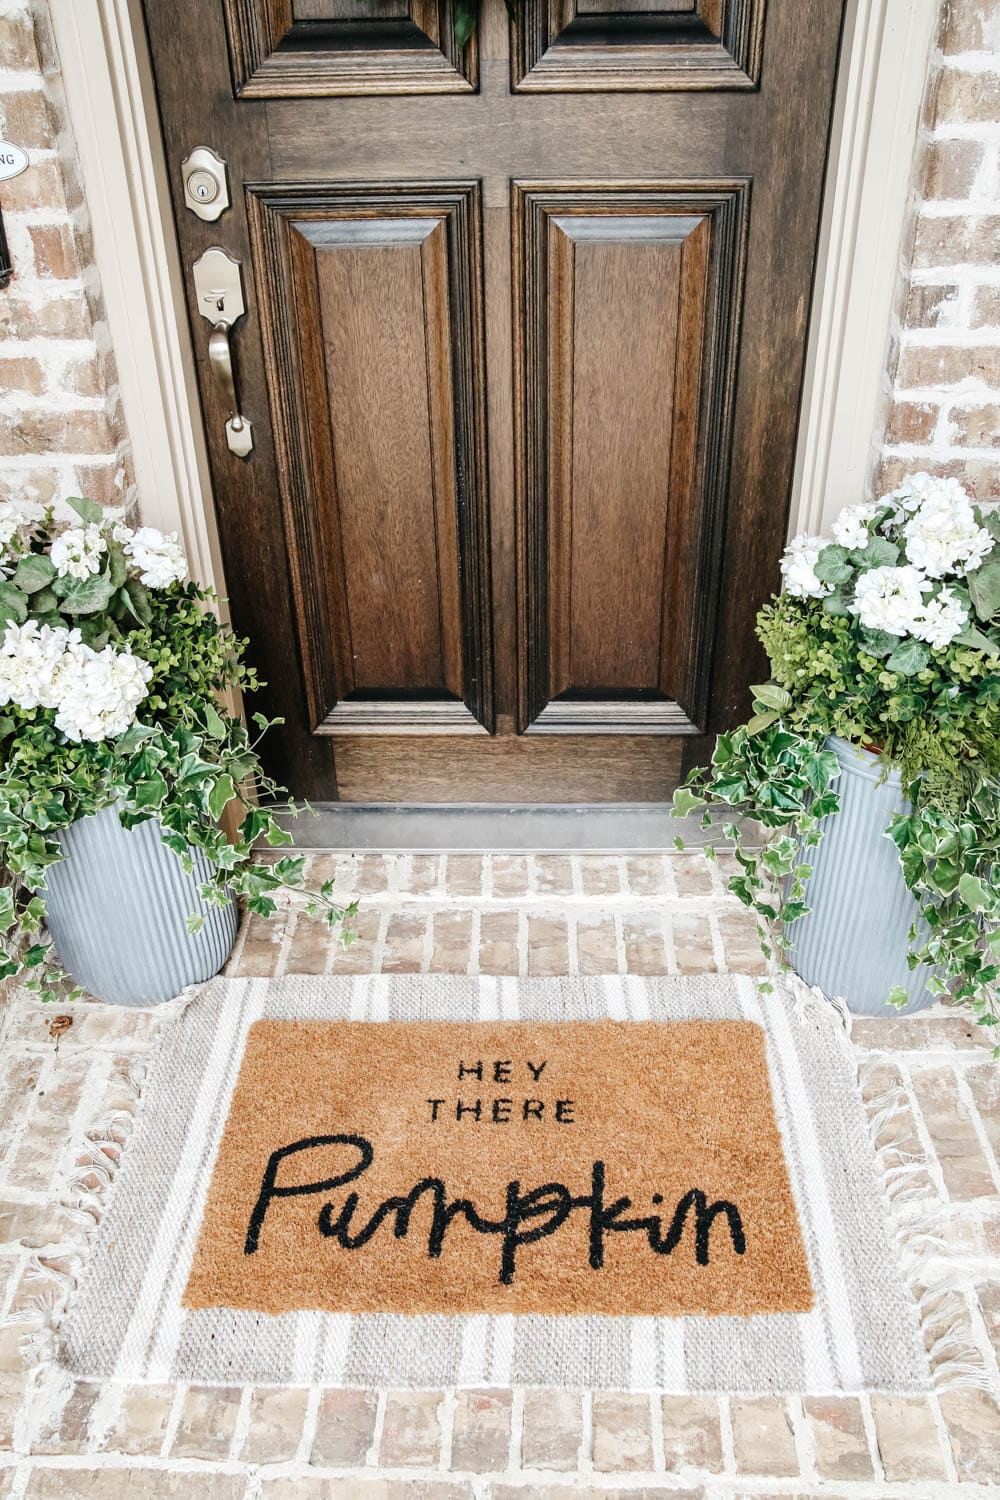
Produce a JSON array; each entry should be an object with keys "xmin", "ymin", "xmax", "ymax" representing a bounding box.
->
[{"xmin": 60, "ymin": 975, "xmax": 930, "ymax": 1394}]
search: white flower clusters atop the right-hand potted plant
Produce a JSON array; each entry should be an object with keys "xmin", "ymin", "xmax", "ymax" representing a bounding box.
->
[{"xmin": 781, "ymin": 474, "xmax": 997, "ymax": 662}]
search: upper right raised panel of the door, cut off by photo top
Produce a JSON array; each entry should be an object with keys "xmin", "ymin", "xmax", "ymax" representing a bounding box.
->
[{"xmin": 511, "ymin": 0, "xmax": 766, "ymax": 93}]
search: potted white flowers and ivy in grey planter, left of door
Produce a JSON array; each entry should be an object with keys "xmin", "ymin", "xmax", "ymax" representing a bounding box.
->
[{"xmin": 0, "ymin": 500, "xmax": 354, "ymax": 1005}]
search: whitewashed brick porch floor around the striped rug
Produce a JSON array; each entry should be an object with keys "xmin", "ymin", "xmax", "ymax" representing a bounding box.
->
[{"xmin": 0, "ymin": 854, "xmax": 1000, "ymax": 1500}]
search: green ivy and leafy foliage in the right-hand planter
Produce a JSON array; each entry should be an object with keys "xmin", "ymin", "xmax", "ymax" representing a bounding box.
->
[{"xmin": 675, "ymin": 585, "xmax": 1000, "ymax": 1044}]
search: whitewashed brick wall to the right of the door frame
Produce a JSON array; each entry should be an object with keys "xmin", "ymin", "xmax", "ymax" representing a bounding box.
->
[{"xmin": 880, "ymin": 0, "xmax": 1000, "ymax": 500}]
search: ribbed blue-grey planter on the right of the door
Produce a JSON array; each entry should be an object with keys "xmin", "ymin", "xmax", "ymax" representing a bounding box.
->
[{"xmin": 789, "ymin": 738, "xmax": 934, "ymax": 1016}]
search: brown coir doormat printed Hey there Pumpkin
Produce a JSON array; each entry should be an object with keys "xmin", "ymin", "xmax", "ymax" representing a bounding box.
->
[{"xmin": 183, "ymin": 1020, "xmax": 813, "ymax": 1316}]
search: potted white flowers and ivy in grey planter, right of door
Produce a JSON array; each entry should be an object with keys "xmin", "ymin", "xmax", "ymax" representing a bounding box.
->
[{"xmin": 675, "ymin": 474, "xmax": 1000, "ymax": 1025}]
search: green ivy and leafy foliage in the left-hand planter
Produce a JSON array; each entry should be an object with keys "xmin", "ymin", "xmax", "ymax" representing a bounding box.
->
[{"xmin": 0, "ymin": 579, "xmax": 357, "ymax": 999}]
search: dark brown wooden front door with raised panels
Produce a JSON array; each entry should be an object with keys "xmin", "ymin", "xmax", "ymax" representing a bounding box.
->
[{"xmin": 144, "ymin": 0, "xmax": 841, "ymax": 803}]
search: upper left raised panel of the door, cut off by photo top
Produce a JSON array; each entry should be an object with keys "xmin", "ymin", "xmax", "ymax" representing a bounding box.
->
[{"xmin": 223, "ymin": 0, "xmax": 478, "ymax": 99}]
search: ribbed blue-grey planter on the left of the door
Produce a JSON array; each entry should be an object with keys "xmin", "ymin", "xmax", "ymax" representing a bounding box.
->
[{"xmin": 43, "ymin": 807, "xmax": 237, "ymax": 1005}]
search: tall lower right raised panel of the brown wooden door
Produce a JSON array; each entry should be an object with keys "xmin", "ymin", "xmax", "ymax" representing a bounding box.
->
[{"xmin": 514, "ymin": 183, "xmax": 747, "ymax": 734}]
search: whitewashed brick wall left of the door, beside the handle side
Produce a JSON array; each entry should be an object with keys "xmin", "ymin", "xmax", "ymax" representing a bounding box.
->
[{"xmin": 0, "ymin": 0, "xmax": 129, "ymax": 504}]
